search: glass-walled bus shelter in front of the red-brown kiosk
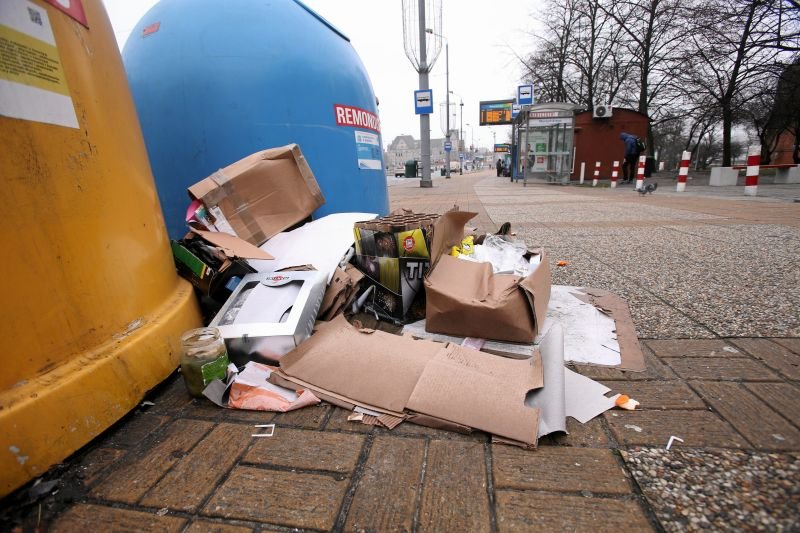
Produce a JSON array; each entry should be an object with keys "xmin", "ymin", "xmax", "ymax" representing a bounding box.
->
[{"xmin": 514, "ymin": 103, "xmax": 576, "ymax": 185}]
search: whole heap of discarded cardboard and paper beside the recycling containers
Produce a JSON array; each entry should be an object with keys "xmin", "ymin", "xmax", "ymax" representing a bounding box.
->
[{"xmin": 173, "ymin": 145, "xmax": 643, "ymax": 447}]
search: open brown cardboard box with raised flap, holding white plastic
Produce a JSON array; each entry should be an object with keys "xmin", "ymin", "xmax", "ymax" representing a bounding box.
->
[{"xmin": 425, "ymin": 211, "xmax": 550, "ymax": 343}]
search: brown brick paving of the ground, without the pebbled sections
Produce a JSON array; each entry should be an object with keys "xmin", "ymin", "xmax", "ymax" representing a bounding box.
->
[{"xmin": 4, "ymin": 170, "xmax": 800, "ymax": 532}]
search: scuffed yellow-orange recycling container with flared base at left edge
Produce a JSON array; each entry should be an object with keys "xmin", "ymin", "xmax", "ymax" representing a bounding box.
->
[{"xmin": 0, "ymin": 0, "xmax": 201, "ymax": 495}]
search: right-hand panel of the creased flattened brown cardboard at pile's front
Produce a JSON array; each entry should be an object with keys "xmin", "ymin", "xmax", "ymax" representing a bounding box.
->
[{"xmin": 408, "ymin": 344, "xmax": 543, "ymax": 444}]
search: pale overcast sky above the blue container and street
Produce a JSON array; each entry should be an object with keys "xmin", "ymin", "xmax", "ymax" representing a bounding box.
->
[{"xmin": 98, "ymin": 0, "xmax": 544, "ymax": 147}]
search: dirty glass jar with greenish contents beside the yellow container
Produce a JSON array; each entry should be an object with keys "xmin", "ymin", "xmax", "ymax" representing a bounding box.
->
[{"xmin": 181, "ymin": 328, "xmax": 228, "ymax": 398}]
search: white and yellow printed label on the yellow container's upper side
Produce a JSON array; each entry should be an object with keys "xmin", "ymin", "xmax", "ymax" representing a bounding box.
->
[{"xmin": 0, "ymin": 0, "xmax": 78, "ymax": 128}]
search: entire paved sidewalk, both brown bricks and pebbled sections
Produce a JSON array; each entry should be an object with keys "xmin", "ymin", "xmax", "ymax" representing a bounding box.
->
[{"xmin": 2, "ymin": 171, "xmax": 800, "ymax": 532}]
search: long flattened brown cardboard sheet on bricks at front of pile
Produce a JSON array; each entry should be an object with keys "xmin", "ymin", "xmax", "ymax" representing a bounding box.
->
[{"xmin": 275, "ymin": 316, "xmax": 542, "ymax": 446}]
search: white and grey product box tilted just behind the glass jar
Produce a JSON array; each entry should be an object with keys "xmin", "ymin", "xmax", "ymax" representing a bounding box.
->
[{"xmin": 210, "ymin": 270, "xmax": 327, "ymax": 366}]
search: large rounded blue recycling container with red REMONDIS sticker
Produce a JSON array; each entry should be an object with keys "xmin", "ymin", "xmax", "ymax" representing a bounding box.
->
[{"xmin": 122, "ymin": 0, "xmax": 389, "ymax": 238}]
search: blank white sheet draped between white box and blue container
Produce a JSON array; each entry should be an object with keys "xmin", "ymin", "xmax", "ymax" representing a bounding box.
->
[{"xmin": 248, "ymin": 213, "xmax": 377, "ymax": 283}]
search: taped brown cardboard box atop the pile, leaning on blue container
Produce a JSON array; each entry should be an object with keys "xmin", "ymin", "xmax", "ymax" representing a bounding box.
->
[{"xmin": 189, "ymin": 144, "xmax": 325, "ymax": 246}]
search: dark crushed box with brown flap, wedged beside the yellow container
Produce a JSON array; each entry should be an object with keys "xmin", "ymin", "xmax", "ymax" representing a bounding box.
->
[{"xmin": 171, "ymin": 230, "xmax": 272, "ymax": 305}]
